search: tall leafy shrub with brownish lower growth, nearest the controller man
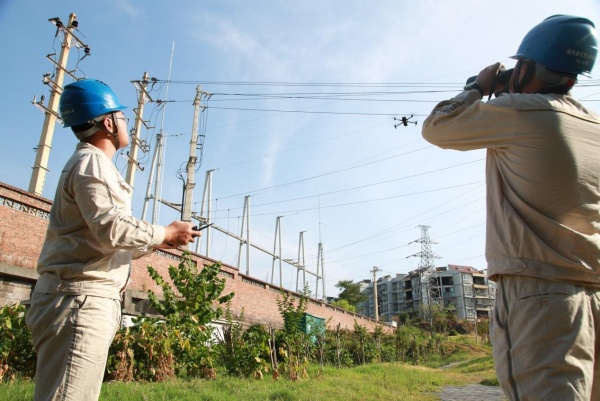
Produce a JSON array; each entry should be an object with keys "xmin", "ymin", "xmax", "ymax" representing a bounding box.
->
[{"xmin": 107, "ymin": 254, "xmax": 234, "ymax": 381}]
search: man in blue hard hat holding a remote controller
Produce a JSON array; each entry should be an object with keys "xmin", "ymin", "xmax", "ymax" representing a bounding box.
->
[{"xmin": 26, "ymin": 79, "xmax": 200, "ymax": 401}]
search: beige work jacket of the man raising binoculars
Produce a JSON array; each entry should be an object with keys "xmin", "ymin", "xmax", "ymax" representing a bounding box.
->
[{"xmin": 422, "ymin": 90, "xmax": 600, "ymax": 286}]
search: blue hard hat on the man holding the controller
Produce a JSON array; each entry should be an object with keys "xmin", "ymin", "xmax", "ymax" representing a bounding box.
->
[{"xmin": 58, "ymin": 79, "xmax": 127, "ymax": 127}]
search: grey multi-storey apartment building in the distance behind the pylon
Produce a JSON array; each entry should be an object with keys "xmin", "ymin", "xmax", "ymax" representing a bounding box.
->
[{"xmin": 357, "ymin": 265, "xmax": 496, "ymax": 322}]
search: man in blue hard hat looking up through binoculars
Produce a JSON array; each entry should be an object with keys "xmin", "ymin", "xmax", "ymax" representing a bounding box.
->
[{"xmin": 422, "ymin": 15, "xmax": 600, "ymax": 401}]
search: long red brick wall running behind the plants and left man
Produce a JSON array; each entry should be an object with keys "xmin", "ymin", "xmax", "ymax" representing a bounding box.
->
[{"xmin": 0, "ymin": 183, "xmax": 390, "ymax": 329}]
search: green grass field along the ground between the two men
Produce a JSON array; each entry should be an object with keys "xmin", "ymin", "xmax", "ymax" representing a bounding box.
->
[{"xmin": 0, "ymin": 349, "xmax": 495, "ymax": 401}]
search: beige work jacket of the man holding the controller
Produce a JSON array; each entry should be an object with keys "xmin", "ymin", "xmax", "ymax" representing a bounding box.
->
[{"xmin": 35, "ymin": 142, "xmax": 165, "ymax": 299}]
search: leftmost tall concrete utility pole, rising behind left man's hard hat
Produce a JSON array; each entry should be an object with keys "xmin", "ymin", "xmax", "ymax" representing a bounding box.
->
[{"xmin": 29, "ymin": 13, "xmax": 90, "ymax": 195}]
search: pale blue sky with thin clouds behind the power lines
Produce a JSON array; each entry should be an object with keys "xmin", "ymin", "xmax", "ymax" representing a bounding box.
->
[{"xmin": 0, "ymin": 0, "xmax": 600, "ymax": 295}]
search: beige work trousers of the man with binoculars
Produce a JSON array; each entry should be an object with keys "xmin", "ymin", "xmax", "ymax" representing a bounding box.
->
[{"xmin": 490, "ymin": 275, "xmax": 600, "ymax": 401}]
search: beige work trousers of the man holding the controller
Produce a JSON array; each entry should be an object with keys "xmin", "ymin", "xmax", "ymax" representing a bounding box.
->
[{"xmin": 25, "ymin": 292, "xmax": 121, "ymax": 401}]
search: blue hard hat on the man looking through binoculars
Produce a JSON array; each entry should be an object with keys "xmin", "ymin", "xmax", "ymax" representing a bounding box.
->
[{"xmin": 512, "ymin": 15, "xmax": 598, "ymax": 75}]
